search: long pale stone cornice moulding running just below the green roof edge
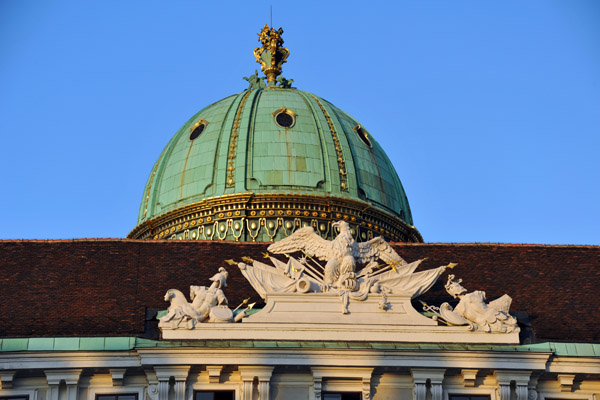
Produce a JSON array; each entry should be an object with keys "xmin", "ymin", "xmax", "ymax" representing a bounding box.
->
[{"xmin": 10, "ymin": 344, "xmax": 600, "ymax": 374}]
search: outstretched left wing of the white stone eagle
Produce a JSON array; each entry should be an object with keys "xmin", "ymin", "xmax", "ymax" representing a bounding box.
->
[{"xmin": 267, "ymin": 226, "xmax": 332, "ymax": 261}]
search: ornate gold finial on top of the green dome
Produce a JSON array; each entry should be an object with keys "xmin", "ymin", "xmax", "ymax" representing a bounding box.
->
[{"xmin": 254, "ymin": 24, "xmax": 290, "ymax": 86}]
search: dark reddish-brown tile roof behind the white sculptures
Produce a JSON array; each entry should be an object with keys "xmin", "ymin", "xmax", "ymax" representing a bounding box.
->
[{"xmin": 0, "ymin": 239, "xmax": 600, "ymax": 342}]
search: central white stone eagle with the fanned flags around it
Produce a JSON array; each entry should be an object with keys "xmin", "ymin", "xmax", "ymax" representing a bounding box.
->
[{"xmin": 238, "ymin": 221, "xmax": 447, "ymax": 314}]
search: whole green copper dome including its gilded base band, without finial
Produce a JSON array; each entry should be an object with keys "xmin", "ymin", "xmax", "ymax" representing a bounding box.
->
[{"xmin": 129, "ymin": 87, "xmax": 422, "ymax": 241}]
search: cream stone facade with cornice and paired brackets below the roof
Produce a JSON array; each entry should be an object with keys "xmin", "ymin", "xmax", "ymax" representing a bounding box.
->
[{"xmin": 0, "ymin": 348, "xmax": 600, "ymax": 400}]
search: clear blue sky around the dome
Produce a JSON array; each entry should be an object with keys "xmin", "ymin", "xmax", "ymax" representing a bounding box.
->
[{"xmin": 0, "ymin": 0, "xmax": 600, "ymax": 245}]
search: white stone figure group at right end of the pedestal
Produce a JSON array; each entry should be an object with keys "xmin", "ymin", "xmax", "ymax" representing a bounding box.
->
[{"xmin": 424, "ymin": 275, "xmax": 520, "ymax": 333}]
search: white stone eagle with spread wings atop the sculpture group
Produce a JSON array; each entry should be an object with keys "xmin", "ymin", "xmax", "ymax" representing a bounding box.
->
[{"xmin": 267, "ymin": 221, "xmax": 406, "ymax": 285}]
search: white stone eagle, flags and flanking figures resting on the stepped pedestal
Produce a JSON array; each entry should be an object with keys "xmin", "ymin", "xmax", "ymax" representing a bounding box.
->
[{"xmin": 159, "ymin": 221, "xmax": 519, "ymax": 333}]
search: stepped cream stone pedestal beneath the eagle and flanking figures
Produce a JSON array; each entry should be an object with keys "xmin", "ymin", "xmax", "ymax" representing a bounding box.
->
[{"xmin": 162, "ymin": 293, "xmax": 519, "ymax": 344}]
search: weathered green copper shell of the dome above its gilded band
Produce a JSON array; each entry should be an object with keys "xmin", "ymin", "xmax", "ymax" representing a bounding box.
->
[{"xmin": 137, "ymin": 85, "xmax": 413, "ymax": 236}]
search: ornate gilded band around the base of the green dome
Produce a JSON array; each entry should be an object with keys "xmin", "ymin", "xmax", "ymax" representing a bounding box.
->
[{"xmin": 127, "ymin": 193, "xmax": 423, "ymax": 242}]
